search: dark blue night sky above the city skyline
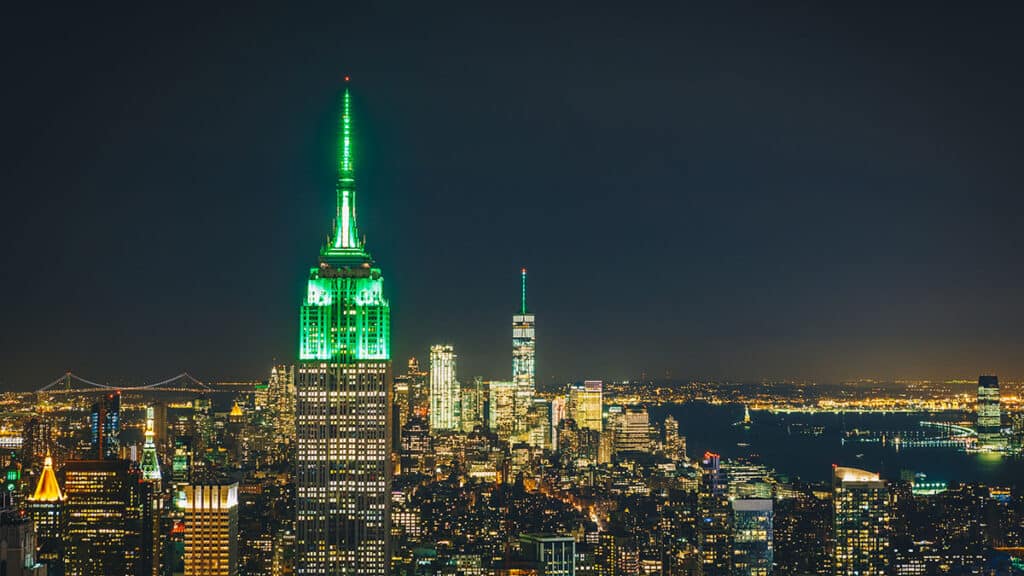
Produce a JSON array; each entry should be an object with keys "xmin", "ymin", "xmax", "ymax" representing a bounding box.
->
[{"xmin": 0, "ymin": 2, "xmax": 1024, "ymax": 389}]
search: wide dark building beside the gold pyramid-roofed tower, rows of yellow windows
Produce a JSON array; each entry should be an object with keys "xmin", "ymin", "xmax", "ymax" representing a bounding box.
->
[{"xmin": 65, "ymin": 459, "xmax": 150, "ymax": 576}]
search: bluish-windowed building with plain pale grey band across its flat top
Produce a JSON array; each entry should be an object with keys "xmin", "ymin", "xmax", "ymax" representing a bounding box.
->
[{"xmin": 732, "ymin": 498, "xmax": 773, "ymax": 576}]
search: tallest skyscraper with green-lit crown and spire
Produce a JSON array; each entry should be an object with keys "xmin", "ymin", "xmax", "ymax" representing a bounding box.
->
[{"xmin": 296, "ymin": 79, "xmax": 392, "ymax": 576}]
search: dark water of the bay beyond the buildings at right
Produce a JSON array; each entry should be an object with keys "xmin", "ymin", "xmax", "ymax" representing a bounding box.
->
[{"xmin": 650, "ymin": 402, "xmax": 1024, "ymax": 486}]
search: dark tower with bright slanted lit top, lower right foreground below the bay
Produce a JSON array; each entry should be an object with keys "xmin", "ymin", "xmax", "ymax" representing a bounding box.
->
[{"xmin": 833, "ymin": 466, "xmax": 890, "ymax": 576}]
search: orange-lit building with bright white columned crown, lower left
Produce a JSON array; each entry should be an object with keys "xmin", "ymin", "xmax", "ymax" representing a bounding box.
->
[{"xmin": 184, "ymin": 484, "xmax": 239, "ymax": 576}]
